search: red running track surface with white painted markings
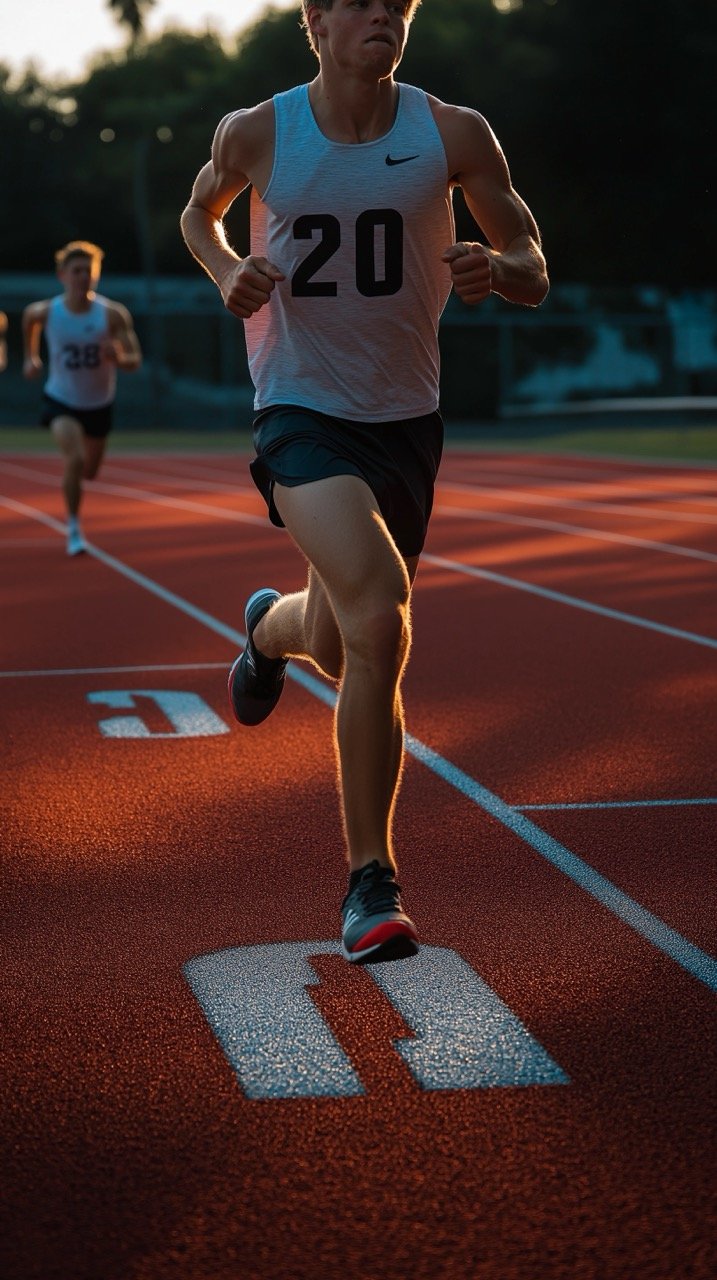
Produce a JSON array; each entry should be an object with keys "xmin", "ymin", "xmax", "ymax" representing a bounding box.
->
[{"xmin": 0, "ymin": 452, "xmax": 717, "ymax": 1280}]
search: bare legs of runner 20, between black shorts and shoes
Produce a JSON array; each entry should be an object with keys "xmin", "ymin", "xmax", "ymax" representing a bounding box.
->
[{"xmin": 254, "ymin": 476, "xmax": 417, "ymax": 870}]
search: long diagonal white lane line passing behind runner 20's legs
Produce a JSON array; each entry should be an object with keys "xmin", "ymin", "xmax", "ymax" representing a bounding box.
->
[{"xmin": 0, "ymin": 499, "xmax": 717, "ymax": 991}]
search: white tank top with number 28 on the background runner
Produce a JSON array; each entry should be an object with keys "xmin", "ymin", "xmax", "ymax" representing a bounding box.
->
[{"xmin": 45, "ymin": 294, "xmax": 117, "ymax": 408}]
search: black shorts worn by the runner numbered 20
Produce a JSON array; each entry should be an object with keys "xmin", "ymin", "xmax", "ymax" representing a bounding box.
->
[{"xmin": 250, "ymin": 404, "xmax": 443, "ymax": 557}]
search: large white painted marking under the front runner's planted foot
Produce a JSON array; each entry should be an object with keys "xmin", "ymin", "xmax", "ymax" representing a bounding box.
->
[{"xmin": 184, "ymin": 941, "xmax": 568, "ymax": 1098}]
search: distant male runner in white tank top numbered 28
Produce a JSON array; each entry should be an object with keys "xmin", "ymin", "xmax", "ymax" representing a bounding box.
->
[{"xmin": 23, "ymin": 241, "xmax": 142, "ymax": 556}]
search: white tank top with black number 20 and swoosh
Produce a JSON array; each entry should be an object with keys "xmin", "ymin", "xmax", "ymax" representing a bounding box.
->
[{"xmin": 245, "ymin": 84, "xmax": 455, "ymax": 422}]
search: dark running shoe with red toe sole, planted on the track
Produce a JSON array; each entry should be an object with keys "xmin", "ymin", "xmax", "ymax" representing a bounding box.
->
[{"xmin": 341, "ymin": 859, "xmax": 419, "ymax": 964}]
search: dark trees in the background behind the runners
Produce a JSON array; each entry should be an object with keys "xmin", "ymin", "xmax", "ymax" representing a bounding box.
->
[{"xmin": 0, "ymin": 0, "xmax": 717, "ymax": 288}]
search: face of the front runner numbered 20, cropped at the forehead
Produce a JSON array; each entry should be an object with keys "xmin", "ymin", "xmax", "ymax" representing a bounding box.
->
[{"xmin": 312, "ymin": 0, "xmax": 408, "ymax": 78}]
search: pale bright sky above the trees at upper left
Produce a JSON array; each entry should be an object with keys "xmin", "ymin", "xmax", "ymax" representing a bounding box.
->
[{"xmin": 0, "ymin": 0, "xmax": 298, "ymax": 79}]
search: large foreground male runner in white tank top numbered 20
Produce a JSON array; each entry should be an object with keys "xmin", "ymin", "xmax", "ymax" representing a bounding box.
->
[{"xmin": 182, "ymin": 0, "xmax": 548, "ymax": 963}]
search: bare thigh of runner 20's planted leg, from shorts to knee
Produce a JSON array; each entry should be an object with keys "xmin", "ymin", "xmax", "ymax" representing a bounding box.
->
[{"xmin": 274, "ymin": 476, "xmax": 410, "ymax": 609}]
